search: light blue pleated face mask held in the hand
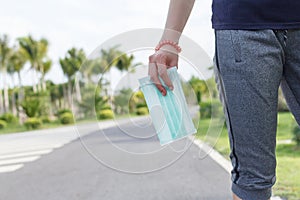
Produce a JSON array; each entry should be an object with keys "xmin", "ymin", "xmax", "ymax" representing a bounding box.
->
[{"xmin": 139, "ymin": 67, "xmax": 197, "ymax": 145}]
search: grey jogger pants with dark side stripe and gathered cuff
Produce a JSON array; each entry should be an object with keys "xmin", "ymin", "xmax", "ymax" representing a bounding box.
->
[{"xmin": 214, "ymin": 30, "xmax": 300, "ymax": 200}]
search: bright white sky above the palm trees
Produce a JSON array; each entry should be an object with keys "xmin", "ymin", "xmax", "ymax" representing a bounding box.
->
[{"xmin": 0, "ymin": 0, "xmax": 214, "ymax": 87}]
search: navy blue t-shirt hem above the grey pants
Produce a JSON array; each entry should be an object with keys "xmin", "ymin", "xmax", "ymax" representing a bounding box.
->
[{"xmin": 212, "ymin": 0, "xmax": 300, "ymax": 29}]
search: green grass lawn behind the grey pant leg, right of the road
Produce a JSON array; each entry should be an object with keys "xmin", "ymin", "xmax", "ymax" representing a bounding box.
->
[{"xmin": 197, "ymin": 112, "xmax": 300, "ymax": 200}]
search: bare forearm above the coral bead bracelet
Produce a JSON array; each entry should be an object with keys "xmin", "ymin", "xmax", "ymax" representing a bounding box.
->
[{"xmin": 161, "ymin": 0, "xmax": 195, "ymax": 42}]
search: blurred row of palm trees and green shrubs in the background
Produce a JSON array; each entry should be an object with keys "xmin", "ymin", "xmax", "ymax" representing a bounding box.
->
[{"xmin": 0, "ymin": 35, "xmax": 296, "ymax": 132}]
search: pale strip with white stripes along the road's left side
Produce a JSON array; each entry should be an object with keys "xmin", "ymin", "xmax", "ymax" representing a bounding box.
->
[{"xmin": 0, "ymin": 117, "xmax": 166, "ymax": 174}]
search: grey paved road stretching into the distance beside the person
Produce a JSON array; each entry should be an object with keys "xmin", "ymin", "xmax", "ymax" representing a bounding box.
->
[{"xmin": 0, "ymin": 119, "xmax": 230, "ymax": 200}]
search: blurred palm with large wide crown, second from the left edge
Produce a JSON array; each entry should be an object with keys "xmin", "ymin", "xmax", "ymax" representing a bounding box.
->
[{"xmin": 18, "ymin": 35, "xmax": 48, "ymax": 92}]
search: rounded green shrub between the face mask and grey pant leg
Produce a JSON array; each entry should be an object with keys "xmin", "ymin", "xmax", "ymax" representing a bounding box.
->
[{"xmin": 200, "ymin": 100, "xmax": 223, "ymax": 118}]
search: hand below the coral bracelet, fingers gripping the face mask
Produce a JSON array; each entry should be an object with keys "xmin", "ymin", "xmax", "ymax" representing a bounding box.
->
[{"xmin": 148, "ymin": 45, "xmax": 178, "ymax": 96}]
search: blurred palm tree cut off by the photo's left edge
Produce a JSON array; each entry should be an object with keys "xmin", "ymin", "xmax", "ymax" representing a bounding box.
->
[{"xmin": 0, "ymin": 35, "xmax": 11, "ymax": 113}]
